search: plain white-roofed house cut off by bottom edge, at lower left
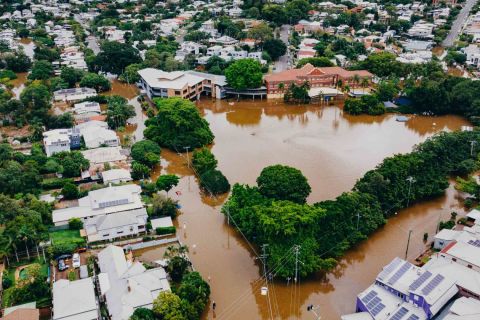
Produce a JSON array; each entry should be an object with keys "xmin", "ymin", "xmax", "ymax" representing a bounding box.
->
[{"xmin": 52, "ymin": 278, "xmax": 101, "ymax": 320}]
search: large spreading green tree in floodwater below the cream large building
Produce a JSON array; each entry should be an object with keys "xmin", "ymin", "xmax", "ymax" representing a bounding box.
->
[{"xmin": 144, "ymin": 98, "xmax": 214, "ymax": 152}]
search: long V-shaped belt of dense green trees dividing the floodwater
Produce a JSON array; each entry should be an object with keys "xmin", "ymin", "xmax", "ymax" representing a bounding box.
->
[{"xmin": 222, "ymin": 132, "xmax": 480, "ymax": 277}]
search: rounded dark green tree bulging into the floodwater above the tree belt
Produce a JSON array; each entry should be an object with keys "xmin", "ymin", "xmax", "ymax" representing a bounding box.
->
[{"xmin": 257, "ymin": 165, "xmax": 312, "ymax": 203}]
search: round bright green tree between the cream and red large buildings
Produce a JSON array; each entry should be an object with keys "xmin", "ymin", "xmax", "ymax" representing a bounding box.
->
[{"xmin": 225, "ymin": 59, "xmax": 263, "ymax": 90}]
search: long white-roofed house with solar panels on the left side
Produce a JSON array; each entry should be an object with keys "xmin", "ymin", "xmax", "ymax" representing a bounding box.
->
[{"xmin": 52, "ymin": 184, "xmax": 147, "ymax": 226}]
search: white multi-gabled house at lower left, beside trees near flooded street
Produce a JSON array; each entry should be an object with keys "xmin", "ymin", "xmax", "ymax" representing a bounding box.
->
[{"xmin": 98, "ymin": 245, "xmax": 170, "ymax": 320}]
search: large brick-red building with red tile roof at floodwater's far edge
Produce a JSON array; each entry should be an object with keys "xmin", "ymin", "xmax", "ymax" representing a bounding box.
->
[{"xmin": 264, "ymin": 63, "xmax": 373, "ymax": 95}]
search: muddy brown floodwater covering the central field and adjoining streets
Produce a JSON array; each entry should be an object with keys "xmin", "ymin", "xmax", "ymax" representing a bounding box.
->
[{"xmin": 135, "ymin": 100, "xmax": 468, "ymax": 320}]
